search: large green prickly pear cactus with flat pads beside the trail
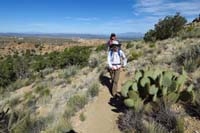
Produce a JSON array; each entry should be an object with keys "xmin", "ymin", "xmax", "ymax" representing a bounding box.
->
[{"xmin": 121, "ymin": 69, "xmax": 193, "ymax": 109}]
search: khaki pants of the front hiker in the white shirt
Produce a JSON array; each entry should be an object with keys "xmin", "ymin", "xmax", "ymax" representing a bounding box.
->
[{"xmin": 110, "ymin": 69, "xmax": 120, "ymax": 96}]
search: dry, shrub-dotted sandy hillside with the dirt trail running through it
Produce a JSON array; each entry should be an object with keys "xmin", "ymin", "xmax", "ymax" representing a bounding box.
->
[{"xmin": 0, "ymin": 25, "xmax": 200, "ymax": 133}]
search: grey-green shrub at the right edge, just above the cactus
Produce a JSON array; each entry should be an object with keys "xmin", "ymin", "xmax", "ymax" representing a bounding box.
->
[{"xmin": 176, "ymin": 44, "xmax": 200, "ymax": 72}]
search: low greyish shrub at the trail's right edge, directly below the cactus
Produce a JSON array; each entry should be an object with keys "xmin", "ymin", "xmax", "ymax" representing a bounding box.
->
[{"xmin": 117, "ymin": 110, "xmax": 145, "ymax": 132}]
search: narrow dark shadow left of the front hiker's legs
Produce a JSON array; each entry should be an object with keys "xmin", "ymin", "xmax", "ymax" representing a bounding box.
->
[{"xmin": 99, "ymin": 74, "xmax": 112, "ymax": 95}]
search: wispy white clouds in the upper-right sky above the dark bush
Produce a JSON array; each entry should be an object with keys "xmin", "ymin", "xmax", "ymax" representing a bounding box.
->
[{"xmin": 130, "ymin": 0, "xmax": 200, "ymax": 32}]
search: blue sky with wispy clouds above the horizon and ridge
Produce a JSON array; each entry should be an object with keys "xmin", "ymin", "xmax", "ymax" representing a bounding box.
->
[{"xmin": 0, "ymin": 0, "xmax": 200, "ymax": 34}]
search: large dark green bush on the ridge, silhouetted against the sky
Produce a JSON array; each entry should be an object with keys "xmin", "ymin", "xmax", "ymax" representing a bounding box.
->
[{"xmin": 144, "ymin": 13, "xmax": 187, "ymax": 41}]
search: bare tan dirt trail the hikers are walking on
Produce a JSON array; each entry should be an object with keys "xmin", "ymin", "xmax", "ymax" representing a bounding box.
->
[{"xmin": 72, "ymin": 71, "xmax": 125, "ymax": 133}]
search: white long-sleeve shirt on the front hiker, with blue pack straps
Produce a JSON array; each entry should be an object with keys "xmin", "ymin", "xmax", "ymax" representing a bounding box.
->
[{"xmin": 107, "ymin": 50, "xmax": 127, "ymax": 69}]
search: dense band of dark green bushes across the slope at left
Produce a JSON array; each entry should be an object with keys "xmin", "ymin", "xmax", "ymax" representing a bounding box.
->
[{"xmin": 0, "ymin": 46, "xmax": 91, "ymax": 88}]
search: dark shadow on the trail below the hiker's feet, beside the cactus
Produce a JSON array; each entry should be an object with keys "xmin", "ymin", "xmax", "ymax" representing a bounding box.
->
[{"xmin": 108, "ymin": 95, "xmax": 127, "ymax": 113}]
